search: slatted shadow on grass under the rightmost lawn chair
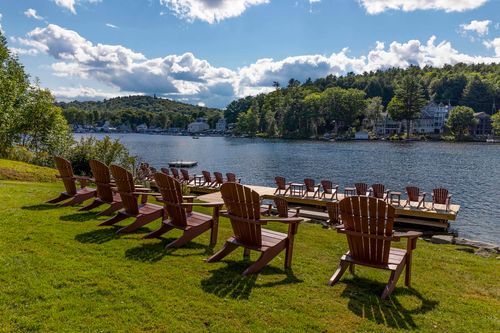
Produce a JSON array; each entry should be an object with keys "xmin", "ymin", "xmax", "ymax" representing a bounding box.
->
[{"xmin": 340, "ymin": 277, "xmax": 439, "ymax": 330}]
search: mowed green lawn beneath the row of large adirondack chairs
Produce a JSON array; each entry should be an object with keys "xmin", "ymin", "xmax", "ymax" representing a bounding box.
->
[{"xmin": 0, "ymin": 181, "xmax": 500, "ymax": 332}]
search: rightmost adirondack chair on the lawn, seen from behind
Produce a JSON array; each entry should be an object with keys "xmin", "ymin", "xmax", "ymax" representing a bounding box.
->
[{"xmin": 328, "ymin": 196, "xmax": 422, "ymax": 299}]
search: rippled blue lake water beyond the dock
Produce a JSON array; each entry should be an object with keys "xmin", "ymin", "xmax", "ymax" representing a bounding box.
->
[{"xmin": 75, "ymin": 134, "xmax": 500, "ymax": 244}]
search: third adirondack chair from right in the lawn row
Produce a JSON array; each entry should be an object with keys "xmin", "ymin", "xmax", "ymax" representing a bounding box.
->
[{"xmin": 145, "ymin": 173, "xmax": 224, "ymax": 248}]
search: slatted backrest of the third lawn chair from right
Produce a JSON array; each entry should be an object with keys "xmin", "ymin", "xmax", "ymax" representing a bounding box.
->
[{"xmin": 154, "ymin": 172, "xmax": 187, "ymax": 226}]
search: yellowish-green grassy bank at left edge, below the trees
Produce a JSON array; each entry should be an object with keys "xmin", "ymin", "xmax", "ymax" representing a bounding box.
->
[{"xmin": 0, "ymin": 159, "xmax": 57, "ymax": 182}]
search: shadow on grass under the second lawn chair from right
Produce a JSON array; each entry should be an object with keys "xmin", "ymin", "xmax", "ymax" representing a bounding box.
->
[{"xmin": 201, "ymin": 259, "xmax": 303, "ymax": 300}]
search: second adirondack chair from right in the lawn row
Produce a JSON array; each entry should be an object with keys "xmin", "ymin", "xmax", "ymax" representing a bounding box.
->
[{"xmin": 207, "ymin": 183, "xmax": 302, "ymax": 275}]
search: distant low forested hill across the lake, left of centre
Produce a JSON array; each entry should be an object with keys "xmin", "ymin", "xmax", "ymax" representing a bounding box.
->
[{"xmin": 57, "ymin": 96, "xmax": 222, "ymax": 129}]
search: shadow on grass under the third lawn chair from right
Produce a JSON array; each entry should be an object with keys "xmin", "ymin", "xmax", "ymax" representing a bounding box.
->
[{"xmin": 125, "ymin": 238, "xmax": 213, "ymax": 263}]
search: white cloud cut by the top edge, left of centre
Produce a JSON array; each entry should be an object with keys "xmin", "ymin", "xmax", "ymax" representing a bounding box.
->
[{"xmin": 160, "ymin": 0, "xmax": 270, "ymax": 24}]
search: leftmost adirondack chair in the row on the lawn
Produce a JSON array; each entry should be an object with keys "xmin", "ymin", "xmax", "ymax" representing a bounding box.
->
[{"xmin": 47, "ymin": 156, "xmax": 97, "ymax": 206}]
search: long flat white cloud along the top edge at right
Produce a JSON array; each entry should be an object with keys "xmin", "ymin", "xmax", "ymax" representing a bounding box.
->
[{"xmin": 359, "ymin": 0, "xmax": 488, "ymax": 15}]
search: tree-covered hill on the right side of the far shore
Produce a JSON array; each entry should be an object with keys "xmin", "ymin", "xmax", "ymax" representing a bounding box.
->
[{"xmin": 228, "ymin": 64, "xmax": 500, "ymax": 138}]
